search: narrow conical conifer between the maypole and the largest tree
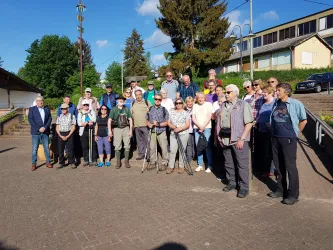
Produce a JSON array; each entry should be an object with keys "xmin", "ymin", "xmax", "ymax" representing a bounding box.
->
[{"xmin": 124, "ymin": 29, "xmax": 148, "ymax": 76}]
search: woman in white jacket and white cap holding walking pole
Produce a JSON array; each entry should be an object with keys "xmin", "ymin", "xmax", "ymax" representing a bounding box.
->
[{"xmin": 77, "ymin": 100, "xmax": 97, "ymax": 166}]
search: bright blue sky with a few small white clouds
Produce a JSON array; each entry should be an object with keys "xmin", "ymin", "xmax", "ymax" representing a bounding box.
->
[{"xmin": 0, "ymin": 0, "xmax": 332, "ymax": 77}]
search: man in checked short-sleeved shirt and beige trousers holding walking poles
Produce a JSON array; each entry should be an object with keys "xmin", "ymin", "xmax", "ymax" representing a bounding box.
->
[{"xmin": 146, "ymin": 94, "xmax": 169, "ymax": 171}]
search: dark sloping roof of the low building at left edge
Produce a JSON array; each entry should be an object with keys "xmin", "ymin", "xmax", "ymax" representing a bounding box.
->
[{"xmin": 0, "ymin": 68, "xmax": 43, "ymax": 93}]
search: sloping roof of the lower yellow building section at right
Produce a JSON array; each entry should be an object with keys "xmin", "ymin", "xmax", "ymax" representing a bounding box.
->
[{"xmin": 226, "ymin": 33, "xmax": 333, "ymax": 62}]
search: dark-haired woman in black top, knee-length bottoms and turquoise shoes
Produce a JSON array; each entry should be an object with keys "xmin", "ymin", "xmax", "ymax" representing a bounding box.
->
[{"xmin": 95, "ymin": 105, "xmax": 111, "ymax": 168}]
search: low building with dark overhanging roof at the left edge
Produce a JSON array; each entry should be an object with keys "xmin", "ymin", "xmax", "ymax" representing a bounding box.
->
[{"xmin": 0, "ymin": 68, "xmax": 41, "ymax": 109}]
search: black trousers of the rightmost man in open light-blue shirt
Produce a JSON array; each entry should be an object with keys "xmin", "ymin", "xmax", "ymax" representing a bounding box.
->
[{"xmin": 272, "ymin": 136, "xmax": 299, "ymax": 199}]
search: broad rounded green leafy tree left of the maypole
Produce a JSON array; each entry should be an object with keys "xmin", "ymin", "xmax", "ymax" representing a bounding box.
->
[{"xmin": 18, "ymin": 35, "xmax": 79, "ymax": 97}]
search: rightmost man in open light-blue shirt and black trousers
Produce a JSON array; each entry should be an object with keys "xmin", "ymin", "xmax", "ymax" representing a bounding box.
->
[{"xmin": 268, "ymin": 83, "xmax": 307, "ymax": 205}]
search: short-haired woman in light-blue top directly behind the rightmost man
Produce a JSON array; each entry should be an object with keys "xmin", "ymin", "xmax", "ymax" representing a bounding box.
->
[{"xmin": 256, "ymin": 86, "xmax": 275, "ymax": 177}]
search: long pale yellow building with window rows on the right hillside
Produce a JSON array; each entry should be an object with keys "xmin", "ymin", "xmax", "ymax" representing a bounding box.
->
[{"xmin": 221, "ymin": 8, "xmax": 333, "ymax": 73}]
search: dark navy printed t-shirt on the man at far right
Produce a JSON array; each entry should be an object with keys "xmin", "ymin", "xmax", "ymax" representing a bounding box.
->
[{"xmin": 272, "ymin": 101, "xmax": 296, "ymax": 138}]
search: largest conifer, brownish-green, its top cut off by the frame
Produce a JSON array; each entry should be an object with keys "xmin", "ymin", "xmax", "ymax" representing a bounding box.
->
[{"xmin": 155, "ymin": 0, "xmax": 233, "ymax": 75}]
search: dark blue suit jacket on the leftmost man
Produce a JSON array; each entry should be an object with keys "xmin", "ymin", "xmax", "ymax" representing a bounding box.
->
[{"xmin": 28, "ymin": 106, "xmax": 52, "ymax": 135}]
